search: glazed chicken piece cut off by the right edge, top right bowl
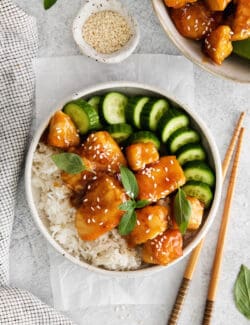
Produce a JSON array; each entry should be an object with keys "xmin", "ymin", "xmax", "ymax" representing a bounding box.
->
[{"xmin": 232, "ymin": 0, "xmax": 250, "ymax": 41}]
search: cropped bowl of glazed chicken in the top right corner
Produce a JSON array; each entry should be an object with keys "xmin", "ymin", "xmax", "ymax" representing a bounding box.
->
[{"xmin": 152, "ymin": 0, "xmax": 250, "ymax": 83}]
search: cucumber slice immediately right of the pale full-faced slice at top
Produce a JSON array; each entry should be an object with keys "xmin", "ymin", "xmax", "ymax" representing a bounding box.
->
[{"xmin": 125, "ymin": 97, "xmax": 149, "ymax": 129}]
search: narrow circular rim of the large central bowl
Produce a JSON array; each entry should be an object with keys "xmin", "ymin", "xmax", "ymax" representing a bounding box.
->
[{"xmin": 24, "ymin": 81, "xmax": 222, "ymax": 278}]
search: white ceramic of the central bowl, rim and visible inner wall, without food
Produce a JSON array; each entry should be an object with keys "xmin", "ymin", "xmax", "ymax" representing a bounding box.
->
[{"xmin": 25, "ymin": 82, "xmax": 222, "ymax": 276}]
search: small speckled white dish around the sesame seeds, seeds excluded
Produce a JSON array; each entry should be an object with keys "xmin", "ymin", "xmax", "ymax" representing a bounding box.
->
[{"xmin": 73, "ymin": 0, "xmax": 140, "ymax": 63}]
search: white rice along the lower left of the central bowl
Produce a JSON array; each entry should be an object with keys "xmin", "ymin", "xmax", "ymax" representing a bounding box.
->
[{"xmin": 32, "ymin": 143, "xmax": 141, "ymax": 271}]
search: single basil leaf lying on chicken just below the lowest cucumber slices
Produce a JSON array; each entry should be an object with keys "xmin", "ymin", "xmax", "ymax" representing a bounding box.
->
[{"xmin": 174, "ymin": 188, "xmax": 191, "ymax": 234}]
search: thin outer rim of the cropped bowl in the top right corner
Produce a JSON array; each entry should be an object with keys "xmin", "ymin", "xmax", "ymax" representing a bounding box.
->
[{"xmin": 151, "ymin": 0, "xmax": 249, "ymax": 84}]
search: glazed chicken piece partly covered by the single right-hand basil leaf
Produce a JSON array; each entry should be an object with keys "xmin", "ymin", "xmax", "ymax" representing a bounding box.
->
[{"xmin": 171, "ymin": 196, "xmax": 204, "ymax": 230}]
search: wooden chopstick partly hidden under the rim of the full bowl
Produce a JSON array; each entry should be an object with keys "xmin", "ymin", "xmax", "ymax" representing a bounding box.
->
[{"xmin": 168, "ymin": 112, "xmax": 245, "ymax": 325}]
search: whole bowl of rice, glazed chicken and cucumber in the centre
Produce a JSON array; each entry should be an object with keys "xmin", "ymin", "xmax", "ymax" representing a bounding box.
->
[{"xmin": 25, "ymin": 82, "xmax": 222, "ymax": 275}]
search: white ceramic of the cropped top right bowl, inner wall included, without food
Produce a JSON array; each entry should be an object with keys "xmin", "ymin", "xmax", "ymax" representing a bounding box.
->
[{"xmin": 152, "ymin": 0, "xmax": 250, "ymax": 83}]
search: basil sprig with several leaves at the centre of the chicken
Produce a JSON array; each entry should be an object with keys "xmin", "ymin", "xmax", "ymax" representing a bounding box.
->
[{"xmin": 118, "ymin": 166, "xmax": 149, "ymax": 236}]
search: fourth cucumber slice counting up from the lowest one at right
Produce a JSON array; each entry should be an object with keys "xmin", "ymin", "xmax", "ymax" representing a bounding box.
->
[{"xmin": 167, "ymin": 127, "xmax": 200, "ymax": 153}]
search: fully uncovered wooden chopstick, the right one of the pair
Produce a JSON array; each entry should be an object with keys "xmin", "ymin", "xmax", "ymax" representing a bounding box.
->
[{"xmin": 202, "ymin": 128, "xmax": 245, "ymax": 325}]
